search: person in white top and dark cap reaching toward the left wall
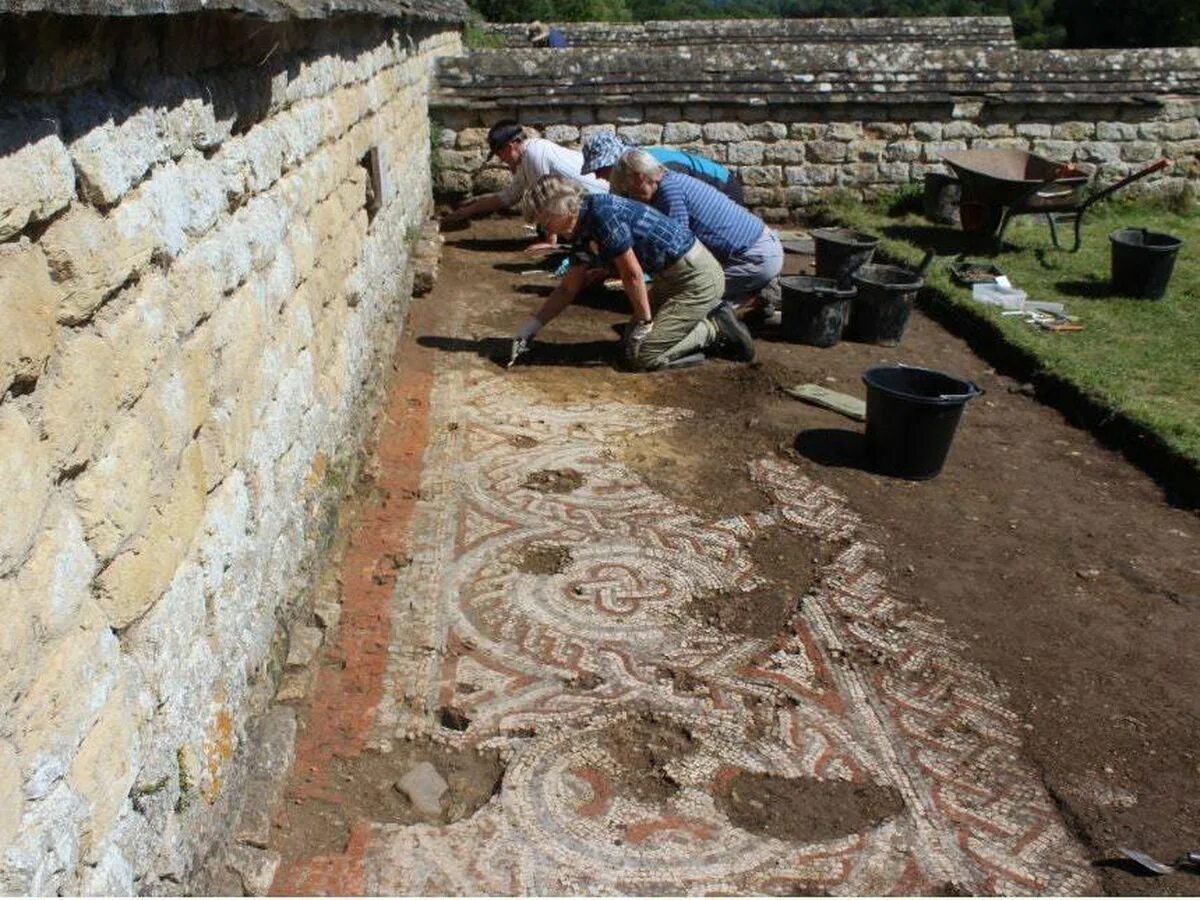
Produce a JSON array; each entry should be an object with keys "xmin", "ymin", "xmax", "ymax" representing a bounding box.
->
[{"xmin": 442, "ymin": 119, "xmax": 608, "ymax": 229}]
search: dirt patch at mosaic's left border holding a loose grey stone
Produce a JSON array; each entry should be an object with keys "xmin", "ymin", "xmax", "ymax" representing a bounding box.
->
[{"xmin": 271, "ymin": 740, "xmax": 504, "ymax": 859}]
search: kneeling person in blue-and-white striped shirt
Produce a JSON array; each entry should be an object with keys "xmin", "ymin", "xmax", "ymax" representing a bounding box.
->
[{"xmin": 610, "ymin": 150, "xmax": 784, "ymax": 308}]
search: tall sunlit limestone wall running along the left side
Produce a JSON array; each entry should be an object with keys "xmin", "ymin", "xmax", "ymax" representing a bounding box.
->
[{"xmin": 0, "ymin": 13, "xmax": 460, "ymax": 894}]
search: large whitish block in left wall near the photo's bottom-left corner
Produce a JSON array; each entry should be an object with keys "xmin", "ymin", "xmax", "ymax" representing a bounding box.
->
[{"xmin": 12, "ymin": 624, "xmax": 120, "ymax": 800}]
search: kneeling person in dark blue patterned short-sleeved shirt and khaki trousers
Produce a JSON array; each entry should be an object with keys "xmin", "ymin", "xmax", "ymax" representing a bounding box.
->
[{"xmin": 509, "ymin": 175, "xmax": 754, "ymax": 371}]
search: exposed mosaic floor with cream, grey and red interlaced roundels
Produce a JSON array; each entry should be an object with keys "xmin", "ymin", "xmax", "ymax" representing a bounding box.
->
[{"xmin": 338, "ymin": 368, "xmax": 1097, "ymax": 895}]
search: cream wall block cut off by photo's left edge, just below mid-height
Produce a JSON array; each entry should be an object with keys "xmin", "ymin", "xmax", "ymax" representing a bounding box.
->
[{"xmin": 0, "ymin": 404, "xmax": 50, "ymax": 575}]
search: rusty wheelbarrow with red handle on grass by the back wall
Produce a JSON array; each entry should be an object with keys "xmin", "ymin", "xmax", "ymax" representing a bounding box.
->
[{"xmin": 942, "ymin": 148, "xmax": 1170, "ymax": 253}]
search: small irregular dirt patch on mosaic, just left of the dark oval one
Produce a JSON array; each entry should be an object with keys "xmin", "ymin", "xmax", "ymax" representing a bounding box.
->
[{"xmin": 600, "ymin": 712, "xmax": 697, "ymax": 803}]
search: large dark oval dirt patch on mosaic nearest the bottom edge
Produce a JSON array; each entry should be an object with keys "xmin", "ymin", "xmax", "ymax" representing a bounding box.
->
[{"xmin": 716, "ymin": 772, "xmax": 904, "ymax": 844}]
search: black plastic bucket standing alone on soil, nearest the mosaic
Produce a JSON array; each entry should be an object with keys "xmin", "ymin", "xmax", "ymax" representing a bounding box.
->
[{"xmin": 863, "ymin": 366, "xmax": 983, "ymax": 481}]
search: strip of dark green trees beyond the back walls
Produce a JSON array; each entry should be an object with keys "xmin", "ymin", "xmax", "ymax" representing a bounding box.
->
[{"xmin": 469, "ymin": 0, "xmax": 1200, "ymax": 48}]
